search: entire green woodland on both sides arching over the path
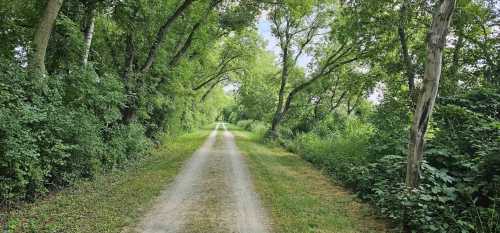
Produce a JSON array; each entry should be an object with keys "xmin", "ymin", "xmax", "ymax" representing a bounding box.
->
[{"xmin": 0, "ymin": 0, "xmax": 500, "ymax": 233}]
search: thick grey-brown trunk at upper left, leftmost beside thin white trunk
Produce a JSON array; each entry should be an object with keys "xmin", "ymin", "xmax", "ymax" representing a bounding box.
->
[{"xmin": 29, "ymin": 0, "xmax": 63, "ymax": 74}]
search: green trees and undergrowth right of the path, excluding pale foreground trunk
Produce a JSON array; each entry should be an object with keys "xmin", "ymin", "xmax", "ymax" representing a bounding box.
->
[{"xmin": 225, "ymin": 0, "xmax": 500, "ymax": 232}]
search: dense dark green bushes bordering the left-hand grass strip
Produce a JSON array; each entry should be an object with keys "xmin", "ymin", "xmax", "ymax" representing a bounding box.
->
[{"xmin": 0, "ymin": 62, "xmax": 223, "ymax": 207}]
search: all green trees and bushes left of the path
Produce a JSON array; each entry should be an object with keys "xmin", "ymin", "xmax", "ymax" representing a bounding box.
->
[{"xmin": 0, "ymin": 0, "xmax": 258, "ymax": 206}]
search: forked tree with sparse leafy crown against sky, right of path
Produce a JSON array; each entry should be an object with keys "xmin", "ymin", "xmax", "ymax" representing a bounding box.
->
[{"xmin": 268, "ymin": 3, "xmax": 363, "ymax": 138}]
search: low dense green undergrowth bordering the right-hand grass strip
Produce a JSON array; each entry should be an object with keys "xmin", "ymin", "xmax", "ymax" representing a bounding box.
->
[{"xmin": 237, "ymin": 88, "xmax": 500, "ymax": 233}]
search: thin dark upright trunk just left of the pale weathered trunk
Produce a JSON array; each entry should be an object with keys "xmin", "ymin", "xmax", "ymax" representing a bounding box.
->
[{"xmin": 398, "ymin": 0, "xmax": 416, "ymax": 105}]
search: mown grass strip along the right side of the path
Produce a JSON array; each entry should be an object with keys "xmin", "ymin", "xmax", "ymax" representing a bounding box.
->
[{"xmin": 232, "ymin": 128, "xmax": 387, "ymax": 233}]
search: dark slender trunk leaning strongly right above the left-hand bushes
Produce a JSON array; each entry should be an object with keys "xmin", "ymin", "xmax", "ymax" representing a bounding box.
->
[{"xmin": 141, "ymin": 0, "xmax": 194, "ymax": 73}]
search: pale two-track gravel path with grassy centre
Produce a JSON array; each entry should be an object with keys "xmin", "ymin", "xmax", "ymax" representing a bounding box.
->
[{"xmin": 136, "ymin": 124, "xmax": 269, "ymax": 233}]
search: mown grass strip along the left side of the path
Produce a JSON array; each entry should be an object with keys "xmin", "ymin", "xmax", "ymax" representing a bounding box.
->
[{"xmin": 0, "ymin": 128, "xmax": 210, "ymax": 233}]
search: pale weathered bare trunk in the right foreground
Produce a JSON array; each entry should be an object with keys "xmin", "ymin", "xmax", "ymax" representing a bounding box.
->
[{"xmin": 406, "ymin": 0, "xmax": 455, "ymax": 188}]
